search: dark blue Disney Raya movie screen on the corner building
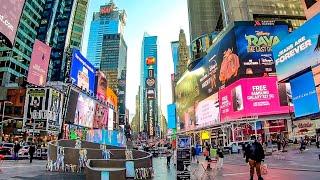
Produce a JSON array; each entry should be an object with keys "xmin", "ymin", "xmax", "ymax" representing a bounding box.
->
[{"xmin": 235, "ymin": 25, "xmax": 288, "ymax": 76}]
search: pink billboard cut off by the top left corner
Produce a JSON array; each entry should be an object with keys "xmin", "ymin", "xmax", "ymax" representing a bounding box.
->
[{"xmin": 0, "ymin": 0, "xmax": 25, "ymax": 47}]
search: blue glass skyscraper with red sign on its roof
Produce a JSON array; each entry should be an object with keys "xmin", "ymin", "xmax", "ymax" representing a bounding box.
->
[{"xmin": 87, "ymin": 1, "xmax": 127, "ymax": 125}]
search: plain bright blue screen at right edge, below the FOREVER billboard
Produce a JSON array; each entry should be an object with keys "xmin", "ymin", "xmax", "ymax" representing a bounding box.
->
[{"xmin": 290, "ymin": 71, "xmax": 320, "ymax": 117}]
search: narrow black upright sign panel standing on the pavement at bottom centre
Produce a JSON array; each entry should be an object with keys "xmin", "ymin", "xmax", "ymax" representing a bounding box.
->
[{"xmin": 177, "ymin": 136, "xmax": 191, "ymax": 180}]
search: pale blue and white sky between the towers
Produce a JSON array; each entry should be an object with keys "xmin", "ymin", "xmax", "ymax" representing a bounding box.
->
[{"xmin": 82, "ymin": 0, "xmax": 189, "ymax": 119}]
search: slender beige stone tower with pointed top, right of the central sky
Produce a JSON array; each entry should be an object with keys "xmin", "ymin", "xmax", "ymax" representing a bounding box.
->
[{"xmin": 177, "ymin": 29, "xmax": 190, "ymax": 78}]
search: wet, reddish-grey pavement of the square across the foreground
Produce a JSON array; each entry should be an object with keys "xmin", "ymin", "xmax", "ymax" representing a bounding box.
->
[{"xmin": 0, "ymin": 148, "xmax": 320, "ymax": 180}]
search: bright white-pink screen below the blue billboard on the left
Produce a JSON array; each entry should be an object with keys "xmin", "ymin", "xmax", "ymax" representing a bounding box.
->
[{"xmin": 74, "ymin": 93, "xmax": 96, "ymax": 128}]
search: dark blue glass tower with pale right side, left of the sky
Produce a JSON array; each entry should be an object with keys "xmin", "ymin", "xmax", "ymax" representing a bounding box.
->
[{"xmin": 37, "ymin": 0, "xmax": 89, "ymax": 81}]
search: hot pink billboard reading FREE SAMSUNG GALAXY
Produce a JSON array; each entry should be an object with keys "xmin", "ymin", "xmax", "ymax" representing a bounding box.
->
[{"xmin": 219, "ymin": 77, "xmax": 289, "ymax": 122}]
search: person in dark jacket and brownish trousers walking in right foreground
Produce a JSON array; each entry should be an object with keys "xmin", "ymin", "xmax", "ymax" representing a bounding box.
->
[{"xmin": 246, "ymin": 136, "xmax": 265, "ymax": 180}]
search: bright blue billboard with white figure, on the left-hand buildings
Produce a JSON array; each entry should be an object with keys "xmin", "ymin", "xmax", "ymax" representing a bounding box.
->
[{"xmin": 70, "ymin": 49, "xmax": 96, "ymax": 93}]
